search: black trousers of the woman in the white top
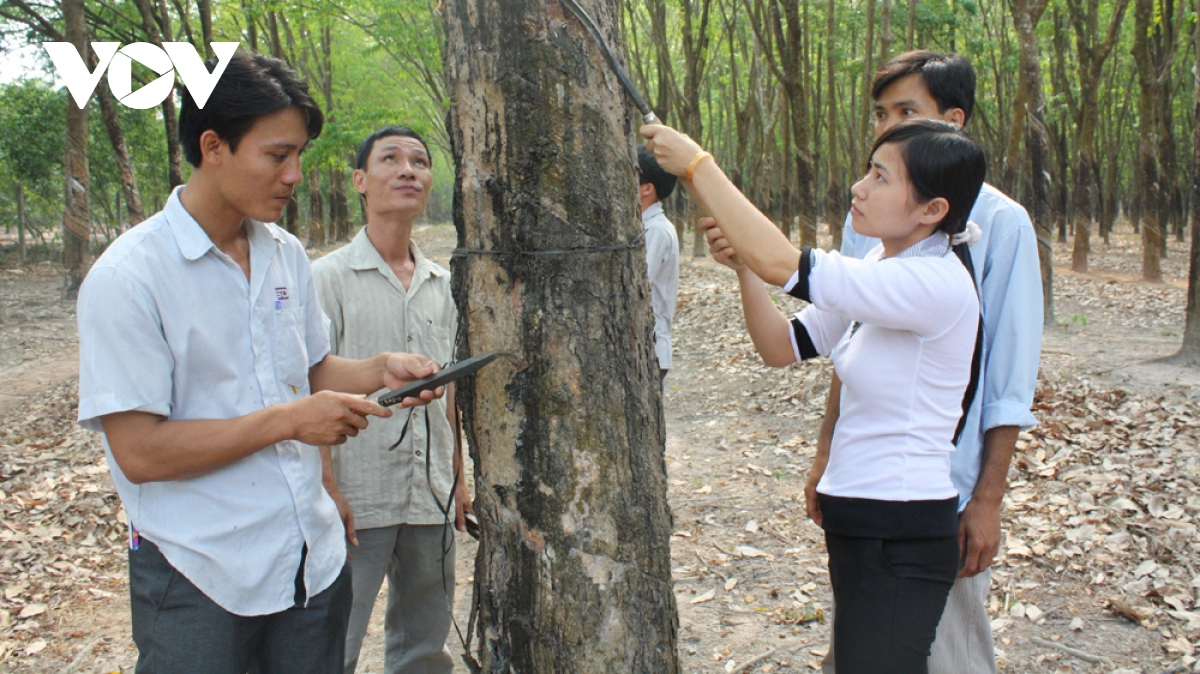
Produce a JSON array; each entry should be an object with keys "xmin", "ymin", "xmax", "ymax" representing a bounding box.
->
[{"xmin": 826, "ymin": 532, "xmax": 959, "ymax": 674}]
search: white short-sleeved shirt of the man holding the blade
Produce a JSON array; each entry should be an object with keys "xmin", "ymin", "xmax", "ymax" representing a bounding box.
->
[{"xmin": 78, "ymin": 187, "xmax": 346, "ymax": 615}]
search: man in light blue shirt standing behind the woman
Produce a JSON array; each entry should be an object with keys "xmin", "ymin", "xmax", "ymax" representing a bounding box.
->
[{"xmin": 805, "ymin": 50, "xmax": 1043, "ymax": 674}]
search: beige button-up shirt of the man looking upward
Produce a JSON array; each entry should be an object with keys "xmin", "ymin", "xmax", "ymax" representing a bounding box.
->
[{"xmin": 313, "ymin": 228, "xmax": 458, "ymax": 529}]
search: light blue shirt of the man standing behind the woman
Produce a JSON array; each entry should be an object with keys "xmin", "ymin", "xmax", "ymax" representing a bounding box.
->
[{"xmin": 841, "ymin": 183, "xmax": 1043, "ymax": 510}]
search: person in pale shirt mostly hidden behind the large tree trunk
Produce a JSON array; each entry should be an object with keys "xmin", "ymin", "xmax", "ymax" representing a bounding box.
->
[{"xmin": 637, "ymin": 146, "xmax": 679, "ymax": 385}]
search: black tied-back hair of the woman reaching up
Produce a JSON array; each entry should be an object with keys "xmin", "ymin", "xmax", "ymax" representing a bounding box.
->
[{"xmin": 871, "ymin": 120, "xmax": 988, "ymax": 236}]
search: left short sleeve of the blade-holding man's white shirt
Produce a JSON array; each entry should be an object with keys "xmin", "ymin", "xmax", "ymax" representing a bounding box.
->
[{"xmin": 76, "ymin": 267, "xmax": 175, "ymax": 432}]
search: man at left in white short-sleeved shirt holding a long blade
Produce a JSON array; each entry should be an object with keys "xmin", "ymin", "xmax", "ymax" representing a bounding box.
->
[{"xmin": 78, "ymin": 52, "xmax": 437, "ymax": 674}]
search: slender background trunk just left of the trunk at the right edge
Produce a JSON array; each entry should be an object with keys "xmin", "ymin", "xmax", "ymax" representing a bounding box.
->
[{"xmin": 1133, "ymin": 0, "xmax": 1170, "ymax": 283}]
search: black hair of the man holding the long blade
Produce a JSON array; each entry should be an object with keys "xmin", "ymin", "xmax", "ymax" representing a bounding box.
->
[{"xmin": 179, "ymin": 49, "xmax": 325, "ymax": 167}]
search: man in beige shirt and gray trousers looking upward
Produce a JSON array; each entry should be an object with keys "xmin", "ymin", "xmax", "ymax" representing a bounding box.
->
[{"xmin": 313, "ymin": 126, "xmax": 472, "ymax": 674}]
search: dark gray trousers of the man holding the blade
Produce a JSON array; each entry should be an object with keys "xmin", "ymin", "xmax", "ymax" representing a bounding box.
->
[{"xmin": 130, "ymin": 538, "xmax": 353, "ymax": 674}]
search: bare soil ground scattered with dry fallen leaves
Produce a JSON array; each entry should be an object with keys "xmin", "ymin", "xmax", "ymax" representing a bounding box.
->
[{"xmin": 0, "ymin": 225, "xmax": 1200, "ymax": 674}]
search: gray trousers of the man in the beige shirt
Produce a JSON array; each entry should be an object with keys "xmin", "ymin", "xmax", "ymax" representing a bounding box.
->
[{"xmin": 344, "ymin": 524, "xmax": 455, "ymax": 674}]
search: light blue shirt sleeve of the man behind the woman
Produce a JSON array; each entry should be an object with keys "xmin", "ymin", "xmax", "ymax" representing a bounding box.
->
[{"xmin": 979, "ymin": 205, "xmax": 1043, "ymax": 432}]
